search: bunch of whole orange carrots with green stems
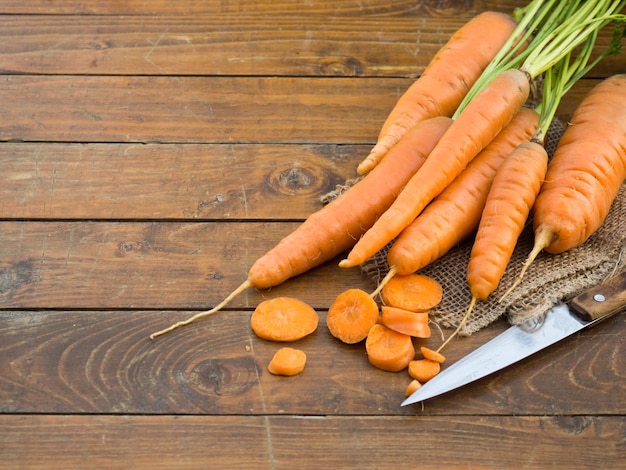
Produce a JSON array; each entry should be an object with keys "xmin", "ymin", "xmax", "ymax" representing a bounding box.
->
[{"xmin": 151, "ymin": 0, "xmax": 626, "ymax": 396}]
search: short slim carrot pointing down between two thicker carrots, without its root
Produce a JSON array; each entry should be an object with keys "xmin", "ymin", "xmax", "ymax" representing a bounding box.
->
[{"xmin": 467, "ymin": 142, "xmax": 548, "ymax": 300}]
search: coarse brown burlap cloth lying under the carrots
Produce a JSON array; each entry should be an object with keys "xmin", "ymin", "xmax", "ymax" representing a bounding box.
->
[{"xmin": 323, "ymin": 120, "xmax": 626, "ymax": 336}]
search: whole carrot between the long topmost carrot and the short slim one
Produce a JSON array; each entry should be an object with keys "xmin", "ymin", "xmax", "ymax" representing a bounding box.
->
[{"xmin": 387, "ymin": 108, "xmax": 539, "ymax": 275}]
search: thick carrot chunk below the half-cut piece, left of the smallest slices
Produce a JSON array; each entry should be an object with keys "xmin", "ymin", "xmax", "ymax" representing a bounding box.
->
[{"xmin": 365, "ymin": 323, "xmax": 415, "ymax": 372}]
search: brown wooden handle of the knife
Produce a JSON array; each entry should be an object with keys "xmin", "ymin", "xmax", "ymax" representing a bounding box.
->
[{"xmin": 570, "ymin": 271, "xmax": 626, "ymax": 321}]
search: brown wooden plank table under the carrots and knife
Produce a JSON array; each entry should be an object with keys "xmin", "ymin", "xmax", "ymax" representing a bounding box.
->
[{"xmin": 0, "ymin": 0, "xmax": 626, "ymax": 469}]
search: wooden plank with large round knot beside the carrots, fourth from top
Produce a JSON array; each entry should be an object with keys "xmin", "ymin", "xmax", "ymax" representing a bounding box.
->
[{"xmin": 0, "ymin": 143, "xmax": 364, "ymax": 220}]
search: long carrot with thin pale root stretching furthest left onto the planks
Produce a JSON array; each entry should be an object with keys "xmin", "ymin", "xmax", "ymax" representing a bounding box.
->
[{"xmin": 150, "ymin": 117, "xmax": 452, "ymax": 339}]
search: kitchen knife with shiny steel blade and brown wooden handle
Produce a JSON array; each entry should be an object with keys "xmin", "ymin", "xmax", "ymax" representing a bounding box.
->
[{"xmin": 402, "ymin": 271, "xmax": 626, "ymax": 406}]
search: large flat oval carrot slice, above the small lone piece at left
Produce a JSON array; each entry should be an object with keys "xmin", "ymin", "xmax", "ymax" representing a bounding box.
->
[{"xmin": 250, "ymin": 297, "xmax": 319, "ymax": 341}]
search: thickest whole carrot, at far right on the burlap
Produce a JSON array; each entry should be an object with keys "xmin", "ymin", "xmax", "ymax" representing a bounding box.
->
[{"xmin": 533, "ymin": 74, "xmax": 626, "ymax": 254}]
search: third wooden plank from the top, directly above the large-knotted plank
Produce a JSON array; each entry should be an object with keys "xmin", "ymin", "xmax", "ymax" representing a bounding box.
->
[{"xmin": 0, "ymin": 76, "xmax": 597, "ymax": 144}]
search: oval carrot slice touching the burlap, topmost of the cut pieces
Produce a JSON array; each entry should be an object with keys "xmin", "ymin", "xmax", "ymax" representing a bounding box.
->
[{"xmin": 381, "ymin": 274, "xmax": 443, "ymax": 312}]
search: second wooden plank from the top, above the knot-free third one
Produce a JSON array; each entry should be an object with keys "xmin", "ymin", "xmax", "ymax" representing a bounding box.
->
[{"xmin": 0, "ymin": 15, "xmax": 623, "ymax": 77}]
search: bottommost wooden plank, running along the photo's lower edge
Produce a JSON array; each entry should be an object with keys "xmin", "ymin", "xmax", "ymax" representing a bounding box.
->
[{"xmin": 0, "ymin": 416, "xmax": 626, "ymax": 470}]
